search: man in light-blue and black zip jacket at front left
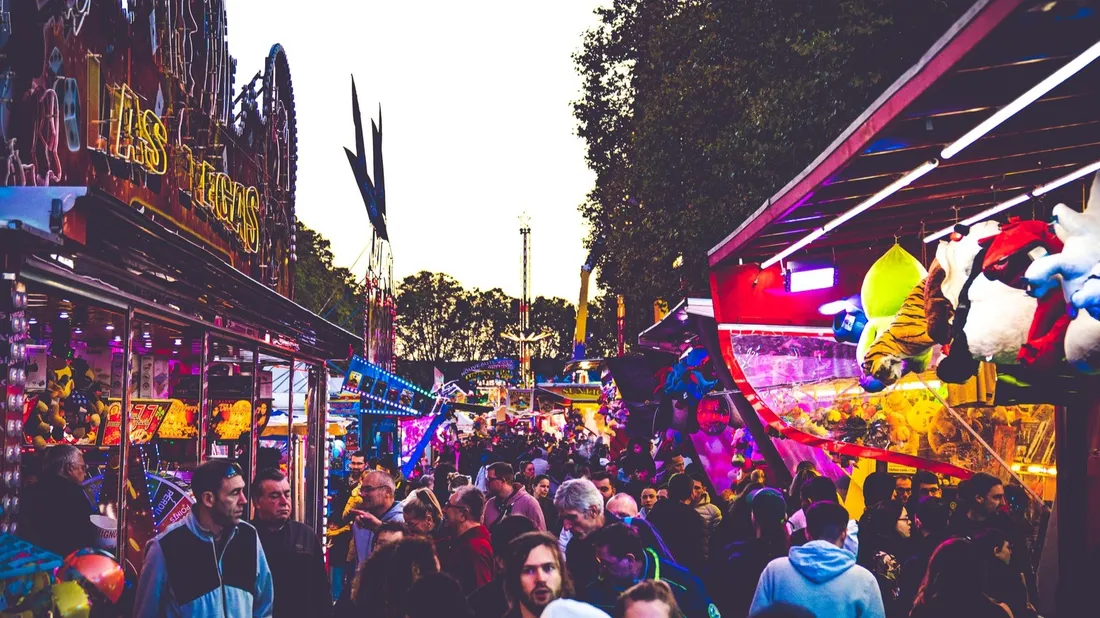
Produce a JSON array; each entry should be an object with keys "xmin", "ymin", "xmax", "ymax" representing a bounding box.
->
[{"xmin": 134, "ymin": 461, "xmax": 273, "ymax": 618}]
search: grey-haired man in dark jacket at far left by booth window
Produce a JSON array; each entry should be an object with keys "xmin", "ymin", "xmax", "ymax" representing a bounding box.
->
[{"xmin": 17, "ymin": 444, "xmax": 97, "ymax": 556}]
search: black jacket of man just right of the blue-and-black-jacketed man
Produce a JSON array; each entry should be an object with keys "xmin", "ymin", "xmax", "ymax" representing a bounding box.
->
[{"xmin": 253, "ymin": 521, "xmax": 332, "ymax": 618}]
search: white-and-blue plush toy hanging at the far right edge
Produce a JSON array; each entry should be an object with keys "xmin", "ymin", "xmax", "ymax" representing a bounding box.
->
[{"xmin": 1024, "ymin": 169, "xmax": 1100, "ymax": 374}]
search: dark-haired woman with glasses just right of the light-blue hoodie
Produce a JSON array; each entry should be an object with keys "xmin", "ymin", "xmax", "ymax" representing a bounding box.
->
[{"xmin": 856, "ymin": 500, "xmax": 913, "ymax": 618}]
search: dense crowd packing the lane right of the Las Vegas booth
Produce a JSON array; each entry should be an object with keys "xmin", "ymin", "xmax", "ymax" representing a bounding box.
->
[{"xmin": 321, "ymin": 428, "xmax": 1037, "ymax": 618}]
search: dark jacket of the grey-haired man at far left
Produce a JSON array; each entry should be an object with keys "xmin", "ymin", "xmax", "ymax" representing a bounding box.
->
[{"xmin": 18, "ymin": 475, "xmax": 98, "ymax": 558}]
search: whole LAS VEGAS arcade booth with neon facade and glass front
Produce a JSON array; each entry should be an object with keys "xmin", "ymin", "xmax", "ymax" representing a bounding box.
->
[{"xmin": 0, "ymin": 0, "xmax": 362, "ymax": 571}]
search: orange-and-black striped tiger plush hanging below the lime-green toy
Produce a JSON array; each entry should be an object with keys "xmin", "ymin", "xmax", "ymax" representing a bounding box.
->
[{"xmin": 862, "ymin": 280, "xmax": 935, "ymax": 386}]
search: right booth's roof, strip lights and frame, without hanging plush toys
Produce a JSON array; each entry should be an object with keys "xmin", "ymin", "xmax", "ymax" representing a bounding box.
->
[{"xmin": 710, "ymin": 0, "xmax": 1100, "ymax": 616}]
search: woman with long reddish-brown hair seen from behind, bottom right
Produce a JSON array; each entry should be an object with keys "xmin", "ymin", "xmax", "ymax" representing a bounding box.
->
[{"xmin": 910, "ymin": 539, "xmax": 1012, "ymax": 618}]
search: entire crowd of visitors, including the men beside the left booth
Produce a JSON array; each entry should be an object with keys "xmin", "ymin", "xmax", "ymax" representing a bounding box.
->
[{"xmin": 12, "ymin": 428, "xmax": 1037, "ymax": 618}]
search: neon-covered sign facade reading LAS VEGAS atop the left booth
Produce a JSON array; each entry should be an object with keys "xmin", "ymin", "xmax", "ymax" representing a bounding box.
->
[{"xmin": 0, "ymin": 0, "xmax": 297, "ymax": 298}]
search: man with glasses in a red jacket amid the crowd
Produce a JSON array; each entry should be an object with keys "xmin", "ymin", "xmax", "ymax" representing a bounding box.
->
[{"xmin": 439, "ymin": 485, "xmax": 493, "ymax": 596}]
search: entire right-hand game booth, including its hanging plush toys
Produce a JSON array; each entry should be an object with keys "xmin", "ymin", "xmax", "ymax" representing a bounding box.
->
[{"xmin": 710, "ymin": 0, "xmax": 1100, "ymax": 616}]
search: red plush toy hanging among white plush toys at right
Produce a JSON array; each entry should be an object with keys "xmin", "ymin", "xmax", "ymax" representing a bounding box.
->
[{"xmin": 980, "ymin": 217, "xmax": 1070, "ymax": 369}]
